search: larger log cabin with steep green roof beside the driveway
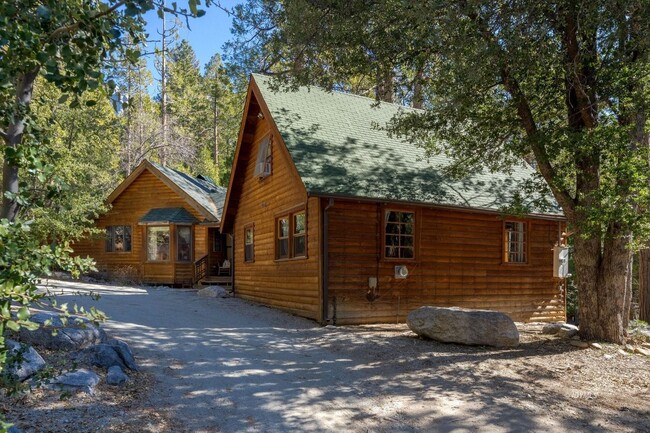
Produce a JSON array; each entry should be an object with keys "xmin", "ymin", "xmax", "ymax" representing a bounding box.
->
[{"xmin": 221, "ymin": 75, "xmax": 565, "ymax": 324}]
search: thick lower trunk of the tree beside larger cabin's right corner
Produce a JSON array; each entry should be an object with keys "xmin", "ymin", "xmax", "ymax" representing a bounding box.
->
[{"xmin": 574, "ymin": 228, "xmax": 632, "ymax": 344}]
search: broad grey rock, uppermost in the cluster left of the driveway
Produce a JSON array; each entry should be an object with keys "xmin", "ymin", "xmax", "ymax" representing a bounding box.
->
[{"xmin": 20, "ymin": 311, "xmax": 107, "ymax": 350}]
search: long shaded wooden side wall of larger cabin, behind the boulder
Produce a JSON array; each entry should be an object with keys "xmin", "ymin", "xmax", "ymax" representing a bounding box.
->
[{"xmin": 321, "ymin": 200, "xmax": 565, "ymax": 324}]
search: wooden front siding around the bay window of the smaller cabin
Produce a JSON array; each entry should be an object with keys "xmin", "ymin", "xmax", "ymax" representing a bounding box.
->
[{"xmin": 73, "ymin": 170, "xmax": 207, "ymax": 285}]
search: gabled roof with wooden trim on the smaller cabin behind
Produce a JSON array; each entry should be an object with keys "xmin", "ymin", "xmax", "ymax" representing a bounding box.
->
[{"xmin": 106, "ymin": 160, "xmax": 226, "ymax": 223}]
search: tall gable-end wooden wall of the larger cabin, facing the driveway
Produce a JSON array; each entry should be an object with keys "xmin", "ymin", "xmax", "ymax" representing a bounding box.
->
[{"xmin": 231, "ymin": 113, "xmax": 321, "ymax": 320}]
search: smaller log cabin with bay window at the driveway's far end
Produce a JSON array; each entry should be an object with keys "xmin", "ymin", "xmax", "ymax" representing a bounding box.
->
[{"xmin": 73, "ymin": 160, "xmax": 232, "ymax": 286}]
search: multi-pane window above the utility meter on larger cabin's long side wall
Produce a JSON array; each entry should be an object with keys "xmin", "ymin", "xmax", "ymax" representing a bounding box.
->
[{"xmin": 384, "ymin": 210, "xmax": 415, "ymax": 259}]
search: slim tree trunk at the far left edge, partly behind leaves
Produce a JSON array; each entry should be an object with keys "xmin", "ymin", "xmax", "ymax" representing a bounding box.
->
[{"xmin": 0, "ymin": 68, "xmax": 39, "ymax": 221}]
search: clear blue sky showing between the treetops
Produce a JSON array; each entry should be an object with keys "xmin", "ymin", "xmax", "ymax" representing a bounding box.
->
[{"xmin": 144, "ymin": 0, "xmax": 238, "ymax": 79}]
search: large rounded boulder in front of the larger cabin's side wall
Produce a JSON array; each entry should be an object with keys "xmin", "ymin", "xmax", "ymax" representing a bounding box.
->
[{"xmin": 406, "ymin": 307, "xmax": 519, "ymax": 347}]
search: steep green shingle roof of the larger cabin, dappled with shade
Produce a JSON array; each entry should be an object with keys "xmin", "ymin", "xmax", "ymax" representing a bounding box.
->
[{"xmin": 253, "ymin": 74, "xmax": 560, "ymax": 215}]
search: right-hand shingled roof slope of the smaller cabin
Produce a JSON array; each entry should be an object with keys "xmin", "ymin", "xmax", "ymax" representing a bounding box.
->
[{"xmin": 150, "ymin": 161, "xmax": 227, "ymax": 221}]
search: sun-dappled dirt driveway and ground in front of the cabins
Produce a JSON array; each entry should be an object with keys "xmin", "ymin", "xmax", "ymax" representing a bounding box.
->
[{"xmin": 0, "ymin": 281, "xmax": 650, "ymax": 433}]
